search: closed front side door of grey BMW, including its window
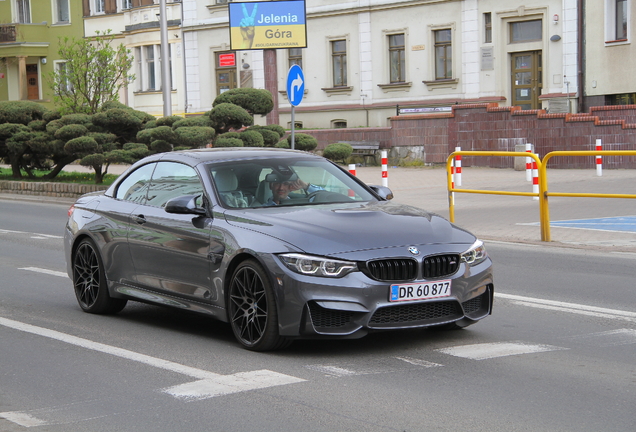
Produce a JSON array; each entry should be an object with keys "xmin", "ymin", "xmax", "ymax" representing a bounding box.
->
[{"xmin": 128, "ymin": 161, "xmax": 218, "ymax": 302}]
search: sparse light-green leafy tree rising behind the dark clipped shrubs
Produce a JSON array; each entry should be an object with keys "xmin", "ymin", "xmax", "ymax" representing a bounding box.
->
[{"xmin": 48, "ymin": 30, "xmax": 135, "ymax": 114}]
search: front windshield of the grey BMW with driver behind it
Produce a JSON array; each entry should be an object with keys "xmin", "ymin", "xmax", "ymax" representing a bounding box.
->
[{"xmin": 208, "ymin": 158, "xmax": 377, "ymax": 208}]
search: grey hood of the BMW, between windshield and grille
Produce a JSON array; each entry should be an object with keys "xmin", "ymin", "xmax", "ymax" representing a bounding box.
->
[{"xmin": 225, "ymin": 201, "xmax": 475, "ymax": 255}]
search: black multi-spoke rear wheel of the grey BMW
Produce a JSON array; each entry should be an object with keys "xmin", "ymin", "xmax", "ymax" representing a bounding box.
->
[{"xmin": 73, "ymin": 238, "xmax": 127, "ymax": 314}]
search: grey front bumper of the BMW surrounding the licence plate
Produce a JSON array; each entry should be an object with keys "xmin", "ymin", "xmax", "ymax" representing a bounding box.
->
[{"xmin": 269, "ymin": 253, "xmax": 494, "ymax": 338}]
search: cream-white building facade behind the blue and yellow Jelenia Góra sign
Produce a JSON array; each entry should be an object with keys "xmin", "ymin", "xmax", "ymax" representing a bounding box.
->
[{"xmin": 182, "ymin": 0, "xmax": 579, "ymax": 128}]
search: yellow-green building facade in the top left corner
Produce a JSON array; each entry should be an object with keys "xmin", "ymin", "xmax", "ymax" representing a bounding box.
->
[{"xmin": 0, "ymin": 0, "xmax": 84, "ymax": 108}]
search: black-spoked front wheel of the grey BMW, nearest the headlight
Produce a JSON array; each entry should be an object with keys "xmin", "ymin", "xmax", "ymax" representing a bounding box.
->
[{"xmin": 228, "ymin": 260, "xmax": 291, "ymax": 351}]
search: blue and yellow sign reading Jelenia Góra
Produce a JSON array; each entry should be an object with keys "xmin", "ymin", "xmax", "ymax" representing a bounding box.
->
[{"xmin": 227, "ymin": 0, "xmax": 307, "ymax": 51}]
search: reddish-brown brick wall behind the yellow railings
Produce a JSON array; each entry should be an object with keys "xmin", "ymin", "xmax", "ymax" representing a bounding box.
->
[{"xmin": 302, "ymin": 103, "xmax": 636, "ymax": 168}]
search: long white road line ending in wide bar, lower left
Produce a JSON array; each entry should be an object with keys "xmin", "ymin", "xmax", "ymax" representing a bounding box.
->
[{"xmin": 0, "ymin": 317, "xmax": 305, "ymax": 408}]
